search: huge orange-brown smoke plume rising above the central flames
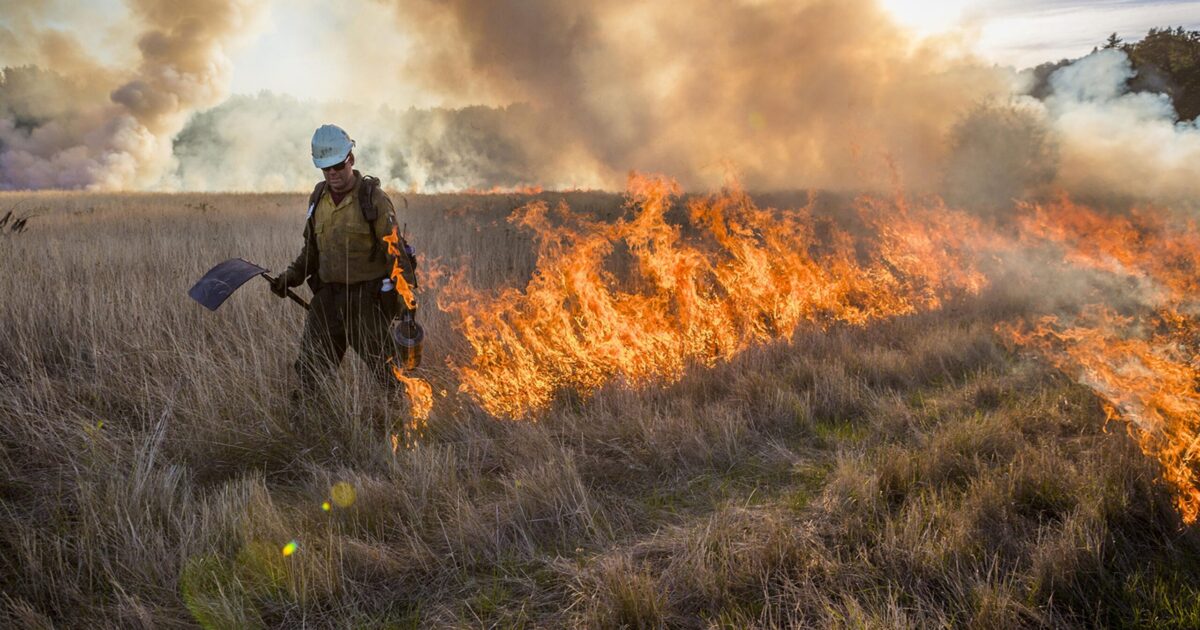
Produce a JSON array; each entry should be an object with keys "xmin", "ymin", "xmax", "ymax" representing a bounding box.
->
[{"xmin": 381, "ymin": 0, "xmax": 1010, "ymax": 193}]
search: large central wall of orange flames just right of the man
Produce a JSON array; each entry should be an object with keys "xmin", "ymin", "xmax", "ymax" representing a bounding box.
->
[{"xmin": 439, "ymin": 174, "xmax": 985, "ymax": 418}]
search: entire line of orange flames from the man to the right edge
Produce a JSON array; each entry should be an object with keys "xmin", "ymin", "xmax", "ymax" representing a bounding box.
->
[{"xmin": 436, "ymin": 174, "xmax": 1200, "ymax": 523}]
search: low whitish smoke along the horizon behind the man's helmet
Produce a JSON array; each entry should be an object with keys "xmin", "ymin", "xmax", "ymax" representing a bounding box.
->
[{"xmin": 162, "ymin": 92, "xmax": 583, "ymax": 192}]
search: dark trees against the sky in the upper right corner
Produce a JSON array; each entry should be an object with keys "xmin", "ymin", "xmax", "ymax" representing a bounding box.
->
[{"xmin": 1032, "ymin": 26, "xmax": 1200, "ymax": 120}]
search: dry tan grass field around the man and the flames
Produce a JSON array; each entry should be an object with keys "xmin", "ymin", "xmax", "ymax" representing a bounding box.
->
[{"xmin": 0, "ymin": 184, "xmax": 1200, "ymax": 628}]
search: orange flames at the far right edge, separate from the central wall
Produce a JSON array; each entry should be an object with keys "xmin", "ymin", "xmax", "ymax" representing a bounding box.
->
[{"xmin": 998, "ymin": 198, "xmax": 1200, "ymax": 523}]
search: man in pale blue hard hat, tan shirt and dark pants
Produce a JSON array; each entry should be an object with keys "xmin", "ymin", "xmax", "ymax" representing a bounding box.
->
[{"xmin": 271, "ymin": 125, "xmax": 416, "ymax": 397}]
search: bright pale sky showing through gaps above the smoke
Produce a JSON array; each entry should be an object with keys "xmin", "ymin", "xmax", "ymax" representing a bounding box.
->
[{"xmin": 225, "ymin": 0, "xmax": 1200, "ymax": 102}]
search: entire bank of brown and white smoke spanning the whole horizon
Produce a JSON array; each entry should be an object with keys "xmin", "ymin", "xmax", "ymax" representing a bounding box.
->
[{"xmin": 7, "ymin": 0, "xmax": 1200, "ymax": 202}]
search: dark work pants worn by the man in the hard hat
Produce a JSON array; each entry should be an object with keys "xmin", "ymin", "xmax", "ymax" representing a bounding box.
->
[{"xmin": 295, "ymin": 280, "xmax": 395, "ymax": 392}]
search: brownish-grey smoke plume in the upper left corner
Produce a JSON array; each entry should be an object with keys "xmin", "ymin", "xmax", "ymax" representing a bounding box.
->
[{"xmin": 0, "ymin": 0, "xmax": 262, "ymax": 188}]
